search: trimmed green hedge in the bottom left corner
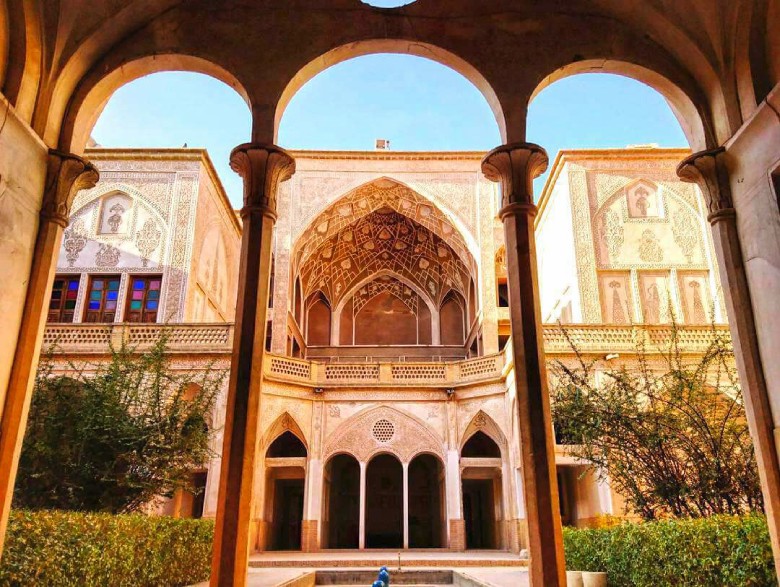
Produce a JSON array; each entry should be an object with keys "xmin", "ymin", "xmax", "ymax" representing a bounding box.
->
[{"xmin": 0, "ymin": 510, "xmax": 214, "ymax": 587}]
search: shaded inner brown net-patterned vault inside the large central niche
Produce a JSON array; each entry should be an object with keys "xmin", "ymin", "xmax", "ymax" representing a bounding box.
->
[{"xmin": 299, "ymin": 207, "xmax": 471, "ymax": 308}]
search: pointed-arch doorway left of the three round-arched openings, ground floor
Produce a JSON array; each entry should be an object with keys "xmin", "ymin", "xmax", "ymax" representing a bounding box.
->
[{"xmin": 265, "ymin": 430, "xmax": 307, "ymax": 550}]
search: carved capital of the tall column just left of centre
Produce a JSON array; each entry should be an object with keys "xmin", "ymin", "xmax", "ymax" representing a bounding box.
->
[{"xmin": 230, "ymin": 143, "xmax": 295, "ymax": 218}]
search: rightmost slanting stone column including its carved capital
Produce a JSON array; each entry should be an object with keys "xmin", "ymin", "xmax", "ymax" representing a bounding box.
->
[{"xmin": 677, "ymin": 147, "xmax": 780, "ymax": 576}]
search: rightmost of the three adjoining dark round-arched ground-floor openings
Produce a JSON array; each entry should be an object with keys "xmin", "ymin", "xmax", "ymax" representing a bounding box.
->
[{"xmin": 409, "ymin": 455, "xmax": 444, "ymax": 548}]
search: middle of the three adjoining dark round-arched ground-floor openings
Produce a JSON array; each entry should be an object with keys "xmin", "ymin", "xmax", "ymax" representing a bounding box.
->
[{"xmin": 366, "ymin": 455, "xmax": 404, "ymax": 548}]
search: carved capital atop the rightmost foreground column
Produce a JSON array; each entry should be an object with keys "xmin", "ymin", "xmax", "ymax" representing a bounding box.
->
[{"xmin": 677, "ymin": 147, "xmax": 735, "ymax": 224}]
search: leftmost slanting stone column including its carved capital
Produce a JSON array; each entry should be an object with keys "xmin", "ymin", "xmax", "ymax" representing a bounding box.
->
[{"xmin": 0, "ymin": 149, "xmax": 98, "ymax": 554}]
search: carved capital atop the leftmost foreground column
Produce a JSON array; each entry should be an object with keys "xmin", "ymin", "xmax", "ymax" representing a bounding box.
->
[{"xmin": 41, "ymin": 149, "xmax": 100, "ymax": 228}]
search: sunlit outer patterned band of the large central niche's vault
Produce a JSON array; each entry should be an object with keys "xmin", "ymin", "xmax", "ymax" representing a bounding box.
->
[{"xmin": 293, "ymin": 178, "xmax": 476, "ymax": 271}]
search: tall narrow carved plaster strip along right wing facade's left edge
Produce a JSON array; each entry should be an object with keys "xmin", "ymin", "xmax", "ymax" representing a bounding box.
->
[{"xmin": 568, "ymin": 165, "xmax": 601, "ymax": 323}]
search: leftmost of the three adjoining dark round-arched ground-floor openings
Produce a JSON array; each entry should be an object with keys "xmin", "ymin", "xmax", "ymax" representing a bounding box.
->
[{"xmin": 322, "ymin": 454, "xmax": 360, "ymax": 548}]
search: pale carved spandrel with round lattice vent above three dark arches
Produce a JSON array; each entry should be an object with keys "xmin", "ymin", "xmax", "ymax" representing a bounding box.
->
[{"xmin": 322, "ymin": 405, "xmax": 444, "ymax": 463}]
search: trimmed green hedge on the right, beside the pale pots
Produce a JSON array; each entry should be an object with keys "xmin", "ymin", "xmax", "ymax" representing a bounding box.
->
[{"xmin": 563, "ymin": 515, "xmax": 777, "ymax": 587}]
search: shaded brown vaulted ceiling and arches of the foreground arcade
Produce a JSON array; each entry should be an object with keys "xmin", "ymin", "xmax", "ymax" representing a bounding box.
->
[{"xmin": 16, "ymin": 0, "xmax": 760, "ymax": 150}]
